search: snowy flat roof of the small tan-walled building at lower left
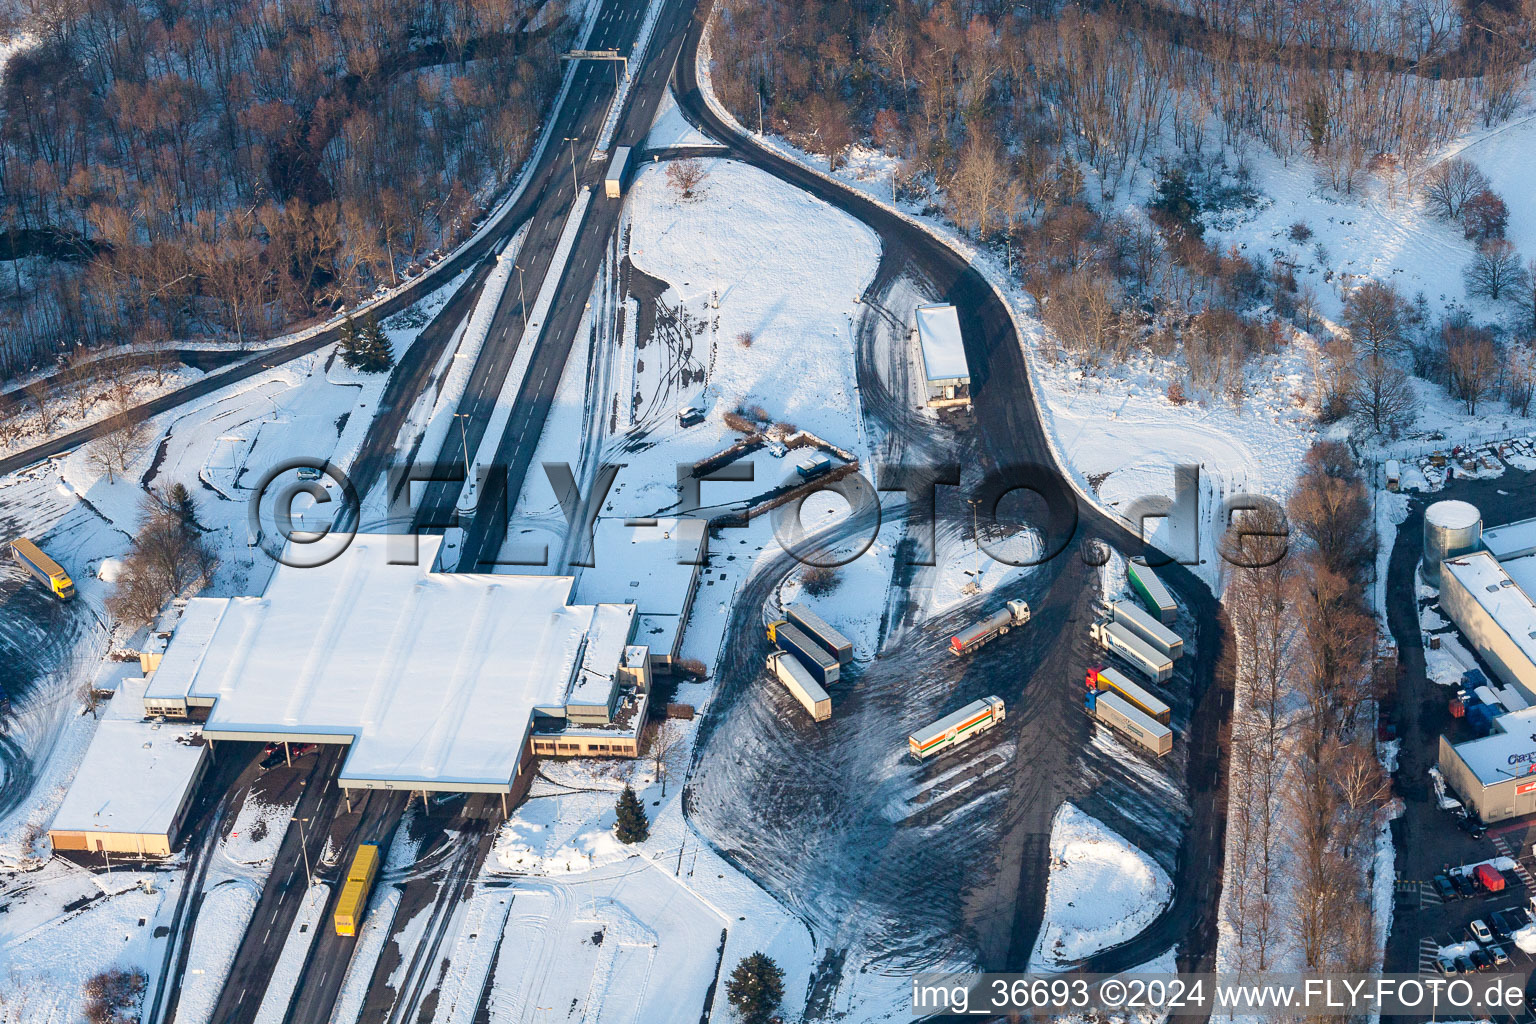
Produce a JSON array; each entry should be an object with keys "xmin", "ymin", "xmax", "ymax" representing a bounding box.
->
[{"xmin": 49, "ymin": 682, "xmax": 207, "ymax": 835}]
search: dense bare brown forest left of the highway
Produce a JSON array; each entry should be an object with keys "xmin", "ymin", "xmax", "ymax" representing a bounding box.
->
[{"xmin": 0, "ymin": 0, "xmax": 574, "ymax": 378}]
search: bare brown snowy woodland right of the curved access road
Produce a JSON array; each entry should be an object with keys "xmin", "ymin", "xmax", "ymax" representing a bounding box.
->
[{"xmin": 713, "ymin": 0, "xmax": 1536, "ymax": 434}]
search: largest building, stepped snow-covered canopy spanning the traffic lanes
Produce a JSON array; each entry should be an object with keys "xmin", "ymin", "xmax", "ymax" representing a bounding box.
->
[{"xmin": 144, "ymin": 534, "xmax": 650, "ymax": 794}]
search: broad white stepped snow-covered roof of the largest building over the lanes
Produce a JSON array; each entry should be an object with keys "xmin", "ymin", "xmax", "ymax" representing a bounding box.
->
[{"xmin": 184, "ymin": 534, "xmax": 633, "ymax": 789}]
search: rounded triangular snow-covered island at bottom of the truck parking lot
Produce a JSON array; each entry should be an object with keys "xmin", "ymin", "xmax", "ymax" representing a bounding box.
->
[{"xmin": 1029, "ymin": 803, "xmax": 1174, "ymax": 970}]
